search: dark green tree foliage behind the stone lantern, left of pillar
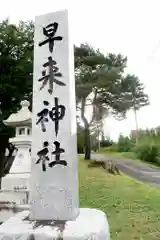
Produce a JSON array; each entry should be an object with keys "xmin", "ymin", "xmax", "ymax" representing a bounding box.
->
[{"xmin": 0, "ymin": 20, "xmax": 34, "ymax": 182}]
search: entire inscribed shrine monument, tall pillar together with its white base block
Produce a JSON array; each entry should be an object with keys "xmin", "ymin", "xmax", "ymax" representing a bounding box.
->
[{"xmin": 0, "ymin": 10, "xmax": 109, "ymax": 240}]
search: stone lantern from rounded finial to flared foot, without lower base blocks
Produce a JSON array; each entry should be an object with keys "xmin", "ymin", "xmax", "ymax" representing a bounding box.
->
[{"xmin": 2, "ymin": 100, "xmax": 32, "ymax": 194}]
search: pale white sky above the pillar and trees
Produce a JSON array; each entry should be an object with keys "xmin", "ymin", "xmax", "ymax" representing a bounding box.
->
[{"xmin": 0, "ymin": 0, "xmax": 160, "ymax": 139}]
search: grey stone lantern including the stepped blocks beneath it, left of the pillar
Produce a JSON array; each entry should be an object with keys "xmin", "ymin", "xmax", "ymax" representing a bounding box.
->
[{"xmin": 0, "ymin": 100, "xmax": 32, "ymax": 222}]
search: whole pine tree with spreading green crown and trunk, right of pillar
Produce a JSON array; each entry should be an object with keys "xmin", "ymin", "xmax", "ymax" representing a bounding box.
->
[{"xmin": 75, "ymin": 44, "xmax": 148, "ymax": 159}]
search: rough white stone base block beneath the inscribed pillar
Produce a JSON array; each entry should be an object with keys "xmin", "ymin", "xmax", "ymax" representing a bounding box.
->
[{"xmin": 0, "ymin": 208, "xmax": 110, "ymax": 240}]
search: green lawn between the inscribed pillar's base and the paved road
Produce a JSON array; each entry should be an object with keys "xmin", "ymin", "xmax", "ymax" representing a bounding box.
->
[{"xmin": 79, "ymin": 160, "xmax": 160, "ymax": 240}]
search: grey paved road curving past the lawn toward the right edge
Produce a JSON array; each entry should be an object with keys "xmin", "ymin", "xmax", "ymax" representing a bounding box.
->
[{"xmin": 91, "ymin": 154, "xmax": 160, "ymax": 187}]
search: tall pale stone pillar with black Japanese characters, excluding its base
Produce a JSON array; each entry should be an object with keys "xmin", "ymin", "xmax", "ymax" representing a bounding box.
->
[{"xmin": 30, "ymin": 11, "xmax": 79, "ymax": 220}]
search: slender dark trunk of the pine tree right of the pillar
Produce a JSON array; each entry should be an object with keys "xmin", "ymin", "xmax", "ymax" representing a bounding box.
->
[{"xmin": 81, "ymin": 98, "xmax": 91, "ymax": 159}]
